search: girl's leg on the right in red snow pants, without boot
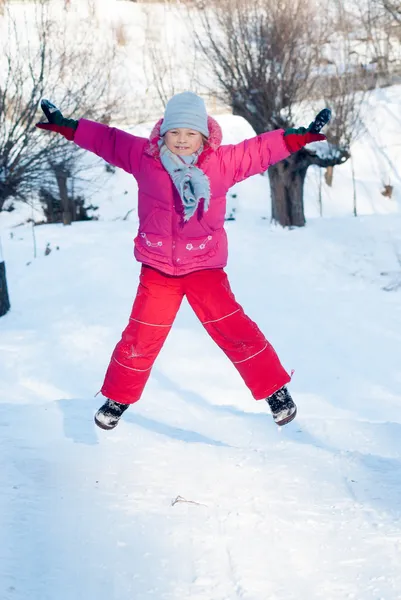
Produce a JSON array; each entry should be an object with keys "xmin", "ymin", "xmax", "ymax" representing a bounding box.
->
[{"xmin": 185, "ymin": 269, "xmax": 291, "ymax": 400}]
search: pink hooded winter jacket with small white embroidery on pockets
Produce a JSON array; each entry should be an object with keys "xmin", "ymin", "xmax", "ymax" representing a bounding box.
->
[{"xmin": 75, "ymin": 117, "xmax": 290, "ymax": 275}]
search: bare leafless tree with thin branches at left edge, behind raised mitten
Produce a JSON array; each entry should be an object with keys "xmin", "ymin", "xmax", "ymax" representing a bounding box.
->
[{"xmin": 0, "ymin": 0, "xmax": 123, "ymax": 223}]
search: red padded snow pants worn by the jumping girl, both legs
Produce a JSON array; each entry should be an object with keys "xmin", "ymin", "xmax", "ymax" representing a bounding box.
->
[{"xmin": 101, "ymin": 265, "xmax": 290, "ymax": 404}]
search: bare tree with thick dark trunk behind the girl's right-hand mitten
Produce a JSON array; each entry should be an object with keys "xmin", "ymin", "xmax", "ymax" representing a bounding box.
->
[{"xmin": 195, "ymin": 0, "xmax": 370, "ymax": 226}]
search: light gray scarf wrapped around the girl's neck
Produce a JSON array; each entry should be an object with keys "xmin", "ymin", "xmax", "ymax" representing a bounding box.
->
[{"xmin": 159, "ymin": 140, "xmax": 210, "ymax": 221}]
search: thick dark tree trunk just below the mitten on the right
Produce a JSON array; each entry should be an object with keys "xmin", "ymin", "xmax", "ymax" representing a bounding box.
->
[{"xmin": 267, "ymin": 155, "xmax": 308, "ymax": 227}]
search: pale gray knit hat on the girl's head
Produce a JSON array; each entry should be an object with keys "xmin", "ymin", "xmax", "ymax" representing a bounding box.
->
[{"xmin": 160, "ymin": 92, "xmax": 209, "ymax": 137}]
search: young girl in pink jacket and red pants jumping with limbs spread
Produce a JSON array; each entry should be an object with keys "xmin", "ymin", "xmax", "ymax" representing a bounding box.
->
[{"xmin": 37, "ymin": 92, "xmax": 325, "ymax": 429}]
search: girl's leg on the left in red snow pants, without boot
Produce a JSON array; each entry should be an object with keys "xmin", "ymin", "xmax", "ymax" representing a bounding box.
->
[{"xmin": 101, "ymin": 266, "xmax": 184, "ymax": 404}]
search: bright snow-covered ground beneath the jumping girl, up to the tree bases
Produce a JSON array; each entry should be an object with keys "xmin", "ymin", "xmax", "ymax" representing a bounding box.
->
[{"xmin": 0, "ymin": 211, "xmax": 401, "ymax": 600}]
